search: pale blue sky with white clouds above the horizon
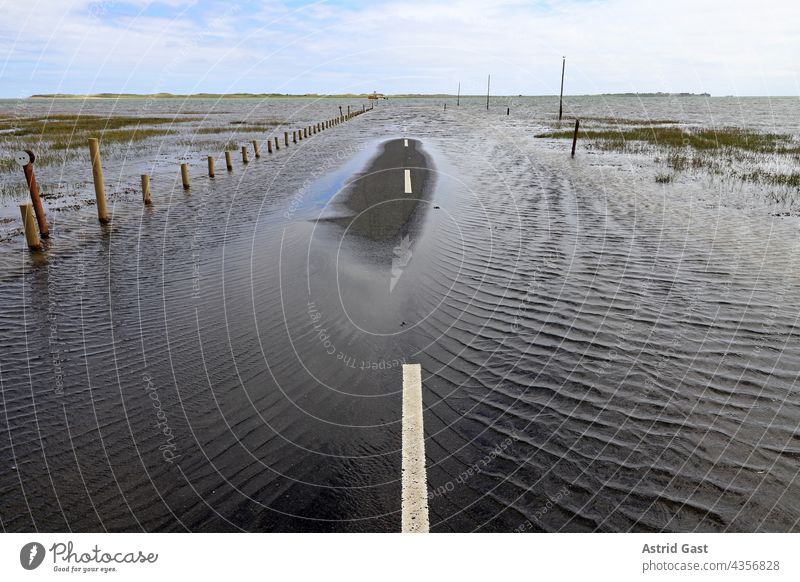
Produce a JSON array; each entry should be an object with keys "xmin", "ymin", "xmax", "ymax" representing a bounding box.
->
[{"xmin": 0, "ymin": 0, "xmax": 800, "ymax": 98}]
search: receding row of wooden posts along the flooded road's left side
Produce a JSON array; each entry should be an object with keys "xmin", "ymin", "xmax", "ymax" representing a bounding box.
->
[{"xmin": 17, "ymin": 105, "xmax": 372, "ymax": 250}]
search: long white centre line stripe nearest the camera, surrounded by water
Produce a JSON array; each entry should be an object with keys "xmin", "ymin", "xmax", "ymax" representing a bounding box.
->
[{"xmin": 400, "ymin": 364, "xmax": 429, "ymax": 533}]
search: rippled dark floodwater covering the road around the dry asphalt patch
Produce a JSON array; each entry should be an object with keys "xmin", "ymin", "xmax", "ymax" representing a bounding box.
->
[{"xmin": 0, "ymin": 103, "xmax": 800, "ymax": 531}]
